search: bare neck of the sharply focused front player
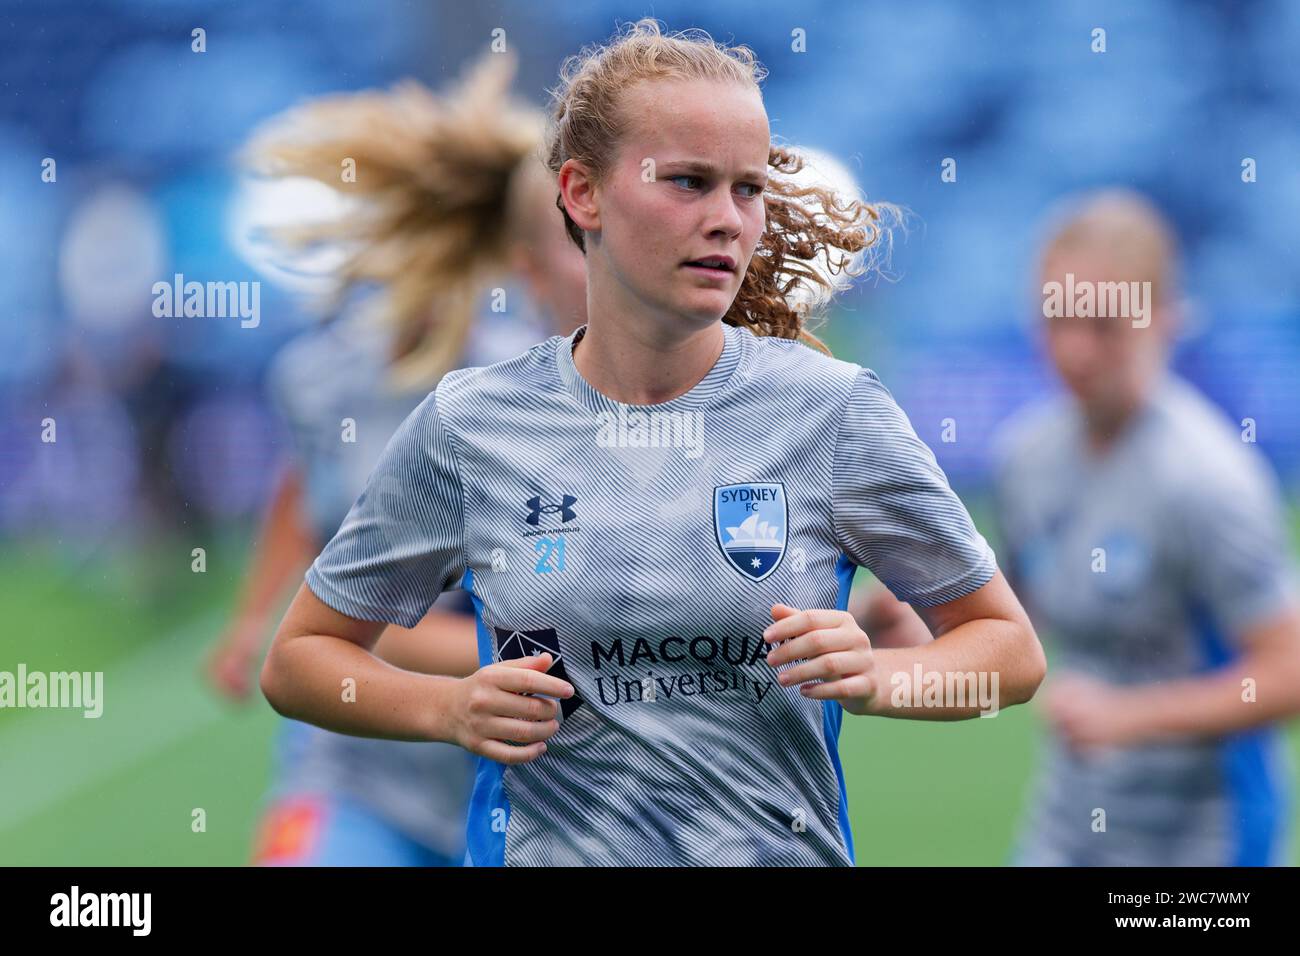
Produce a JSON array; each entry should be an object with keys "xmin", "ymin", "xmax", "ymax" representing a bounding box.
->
[{"xmin": 573, "ymin": 293, "xmax": 727, "ymax": 405}]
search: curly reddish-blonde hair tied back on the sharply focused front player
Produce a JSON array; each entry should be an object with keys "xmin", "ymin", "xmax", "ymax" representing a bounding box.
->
[{"xmin": 545, "ymin": 18, "xmax": 901, "ymax": 355}]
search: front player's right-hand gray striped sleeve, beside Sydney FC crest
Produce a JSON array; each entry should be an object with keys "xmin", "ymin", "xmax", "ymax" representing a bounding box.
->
[{"xmin": 835, "ymin": 368, "xmax": 997, "ymax": 607}]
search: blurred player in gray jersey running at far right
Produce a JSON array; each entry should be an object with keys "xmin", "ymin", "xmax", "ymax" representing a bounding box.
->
[{"xmin": 996, "ymin": 191, "xmax": 1300, "ymax": 866}]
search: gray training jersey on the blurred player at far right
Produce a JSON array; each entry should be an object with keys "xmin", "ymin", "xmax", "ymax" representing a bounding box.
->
[{"xmin": 996, "ymin": 375, "xmax": 1295, "ymax": 866}]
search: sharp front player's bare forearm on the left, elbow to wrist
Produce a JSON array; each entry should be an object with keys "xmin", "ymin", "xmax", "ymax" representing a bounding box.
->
[{"xmin": 261, "ymin": 635, "xmax": 456, "ymax": 740}]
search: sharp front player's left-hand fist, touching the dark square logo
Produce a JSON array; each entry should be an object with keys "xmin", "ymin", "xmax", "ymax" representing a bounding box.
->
[{"xmin": 452, "ymin": 654, "xmax": 575, "ymax": 763}]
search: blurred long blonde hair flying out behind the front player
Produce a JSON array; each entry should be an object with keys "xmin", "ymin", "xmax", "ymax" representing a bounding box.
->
[{"xmin": 243, "ymin": 53, "xmax": 545, "ymax": 386}]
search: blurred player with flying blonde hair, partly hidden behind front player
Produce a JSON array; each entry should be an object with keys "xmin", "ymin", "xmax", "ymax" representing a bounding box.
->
[{"xmin": 211, "ymin": 56, "xmax": 586, "ymax": 865}]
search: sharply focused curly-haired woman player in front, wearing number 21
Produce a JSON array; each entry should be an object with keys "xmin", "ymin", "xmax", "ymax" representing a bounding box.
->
[{"xmin": 261, "ymin": 21, "xmax": 1044, "ymax": 865}]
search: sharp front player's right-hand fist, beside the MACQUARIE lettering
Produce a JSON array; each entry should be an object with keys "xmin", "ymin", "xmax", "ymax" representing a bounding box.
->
[{"xmin": 763, "ymin": 604, "xmax": 876, "ymax": 714}]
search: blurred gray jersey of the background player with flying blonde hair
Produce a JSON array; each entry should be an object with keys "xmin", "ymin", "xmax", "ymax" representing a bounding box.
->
[{"xmin": 269, "ymin": 312, "xmax": 536, "ymax": 862}]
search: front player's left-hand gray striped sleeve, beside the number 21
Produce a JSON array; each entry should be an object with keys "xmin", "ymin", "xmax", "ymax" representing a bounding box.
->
[{"xmin": 307, "ymin": 392, "xmax": 465, "ymax": 627}]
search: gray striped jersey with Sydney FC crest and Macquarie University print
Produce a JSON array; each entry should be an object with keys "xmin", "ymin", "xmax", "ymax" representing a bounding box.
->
[{"xmin": 307, "ymin": 326, "xmax": 996, "ymax": 865}]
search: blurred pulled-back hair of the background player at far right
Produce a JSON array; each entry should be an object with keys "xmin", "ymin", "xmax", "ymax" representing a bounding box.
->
[{"xmin": 1041, "ymin": 187, "xmax": 1179, "ymax": 303}]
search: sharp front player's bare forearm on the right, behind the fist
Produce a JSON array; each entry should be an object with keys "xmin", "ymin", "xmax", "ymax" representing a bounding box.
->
[{"xmin": 870, "ymin": 618, "xmax": 1045, "ymax": 721}]
